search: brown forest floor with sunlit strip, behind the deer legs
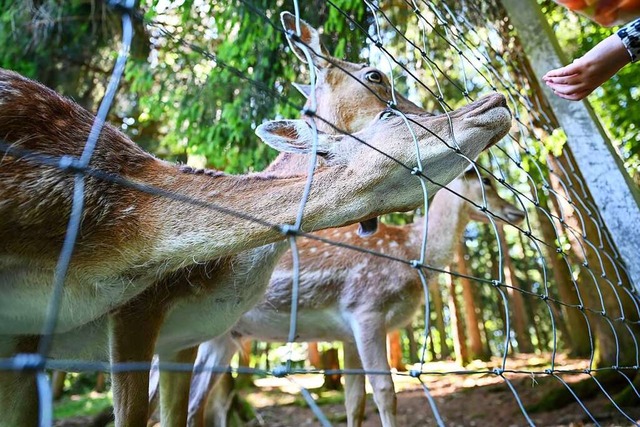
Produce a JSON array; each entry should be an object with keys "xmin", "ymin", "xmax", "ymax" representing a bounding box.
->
[{"xmin": 56, "ymin": 355, "xmax": 640, "ymax": 427}]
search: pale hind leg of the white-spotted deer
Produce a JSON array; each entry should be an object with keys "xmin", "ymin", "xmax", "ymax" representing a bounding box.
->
[{"xmin": 188, "ymin": 333, "xmax": 238, "ymax": 427}]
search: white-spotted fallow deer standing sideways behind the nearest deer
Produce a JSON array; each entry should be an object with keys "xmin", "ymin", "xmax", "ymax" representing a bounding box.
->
[{"xmin": 189, "ymin": 169, "xmax": 524, "ymax": 426}]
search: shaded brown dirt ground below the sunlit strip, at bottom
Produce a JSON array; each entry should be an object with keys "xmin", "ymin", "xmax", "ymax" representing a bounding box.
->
[{"xmin": 245, "ymin": 378, "xmax": 640, "ymax": 427}]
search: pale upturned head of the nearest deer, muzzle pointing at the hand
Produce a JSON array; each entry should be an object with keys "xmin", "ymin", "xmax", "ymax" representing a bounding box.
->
[{"xmin": 256, "ymin": 94, "xmax": 511, "ymax": 217}]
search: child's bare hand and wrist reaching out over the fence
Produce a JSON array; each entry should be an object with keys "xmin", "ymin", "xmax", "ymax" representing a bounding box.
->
[{"xmin": 542, "ymin": 34, "xmax": 631, "ymax": 101}]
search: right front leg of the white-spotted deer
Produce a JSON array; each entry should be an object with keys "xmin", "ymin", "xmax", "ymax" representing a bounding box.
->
[{"xmin": 352, "ymin": 312, "xmax": 396, "ymax": 427}]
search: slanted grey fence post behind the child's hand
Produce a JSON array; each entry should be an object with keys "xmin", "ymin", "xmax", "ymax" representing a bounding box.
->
[{"xmin": 500, "ymin": 0, "xmax": 640, "ymax": 291}]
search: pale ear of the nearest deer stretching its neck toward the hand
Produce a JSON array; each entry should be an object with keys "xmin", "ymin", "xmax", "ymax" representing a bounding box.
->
[{"xmin": 256, "ymin": 120, "xmax": 340, "ymax": 155}]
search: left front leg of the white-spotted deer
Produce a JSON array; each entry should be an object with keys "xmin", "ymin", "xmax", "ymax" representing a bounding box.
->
[{"xmin": 342, "ymin": 342, "xmax": 367, "ymax": 427}]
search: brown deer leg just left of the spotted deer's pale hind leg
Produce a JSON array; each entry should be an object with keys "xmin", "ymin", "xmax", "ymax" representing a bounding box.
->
[{"xmin": 160, "ymin": 346, "xmax": 198, "ymax": 427}]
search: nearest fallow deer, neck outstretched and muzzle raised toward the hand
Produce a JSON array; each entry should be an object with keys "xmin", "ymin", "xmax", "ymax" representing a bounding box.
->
[{"xmin": 0, "ymin": 13, "xmax": 509, "ymax": 425}]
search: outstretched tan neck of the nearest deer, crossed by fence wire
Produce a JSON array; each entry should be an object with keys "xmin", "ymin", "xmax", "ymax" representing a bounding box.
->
[{"xmin": 145, "ymin": 158, "xmax": 370, "ymax": 269}]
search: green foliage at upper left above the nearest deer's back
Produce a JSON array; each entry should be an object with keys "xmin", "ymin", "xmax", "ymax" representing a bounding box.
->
[{"xmin": 0, "ymin": 0, "xmax": 364, "ymax": 172}]
